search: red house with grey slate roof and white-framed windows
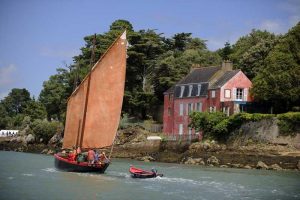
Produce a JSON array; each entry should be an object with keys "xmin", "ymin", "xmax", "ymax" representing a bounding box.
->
[{"xmin": 163, "ymin": 61, "xmax": 252, "ymax": 136}]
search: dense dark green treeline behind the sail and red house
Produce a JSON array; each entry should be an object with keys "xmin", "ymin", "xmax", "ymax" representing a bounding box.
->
[{"xmin": 0, "ymin": 20, "xmax": 300, "ymax": 133}]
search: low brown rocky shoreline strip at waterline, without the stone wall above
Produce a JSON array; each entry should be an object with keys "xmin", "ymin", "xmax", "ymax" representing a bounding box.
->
[{"xmin": 0, "ymin": 127, "xmax": 300, "ymax": 171}]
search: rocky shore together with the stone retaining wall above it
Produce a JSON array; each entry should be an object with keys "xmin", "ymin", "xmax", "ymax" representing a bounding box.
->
[{"xmin": 0, "ymin": 113, "xmax": 300, "ymax": 171}]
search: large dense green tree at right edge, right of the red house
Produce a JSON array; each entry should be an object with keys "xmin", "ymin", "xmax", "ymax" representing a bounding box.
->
[{"xmin": 252, "ymin": 23, "xmax": 300, "ymax": 113}]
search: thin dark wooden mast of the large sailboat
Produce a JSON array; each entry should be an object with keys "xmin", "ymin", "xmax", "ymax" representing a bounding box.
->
[{"xmin": 79, "ymin": 33, "xmax": 96, "ymax": 148}]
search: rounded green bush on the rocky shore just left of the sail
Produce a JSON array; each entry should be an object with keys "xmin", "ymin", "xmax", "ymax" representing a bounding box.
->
[{"xmin": 30, "ymin": 119, "xmax": 63, "ymax": 144}]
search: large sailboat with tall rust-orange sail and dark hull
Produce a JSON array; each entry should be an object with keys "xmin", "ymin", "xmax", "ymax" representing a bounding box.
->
[{"xmin": 54, "ymin": 31, "xmax": 127, "ymax": 173}]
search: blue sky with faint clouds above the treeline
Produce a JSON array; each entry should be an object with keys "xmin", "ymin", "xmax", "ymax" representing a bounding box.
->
[{"xmin": 0, "ymin": 0, "xmax": 300, "ymax": 99}]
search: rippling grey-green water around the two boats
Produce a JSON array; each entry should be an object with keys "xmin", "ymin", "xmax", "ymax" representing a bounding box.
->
[{"xmin": 0, "ymin": 151, "xmax": 300, "ymax": 200}]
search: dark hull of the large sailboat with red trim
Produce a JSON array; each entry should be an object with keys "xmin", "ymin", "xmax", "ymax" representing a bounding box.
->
[{"xmin": 54, "ymin": 154, "xmax": 109, "ymax": 173}]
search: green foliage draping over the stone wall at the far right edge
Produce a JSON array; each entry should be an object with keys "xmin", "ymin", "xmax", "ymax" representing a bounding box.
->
[{"xmin": 277, "ymin": 112, "xmax": 300, "ymax": 135}]
